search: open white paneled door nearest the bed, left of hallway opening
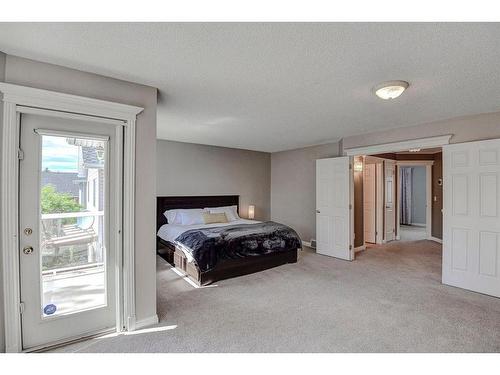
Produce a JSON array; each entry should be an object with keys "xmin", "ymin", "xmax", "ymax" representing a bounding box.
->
[{"xmin": 316, "ymin": 156, "xmax": 354, "ymax": 260}]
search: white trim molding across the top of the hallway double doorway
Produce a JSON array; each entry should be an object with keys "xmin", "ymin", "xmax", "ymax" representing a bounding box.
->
[{"xmin": 344, "ymin": 134, "xmax": 452, "ymax": 156}]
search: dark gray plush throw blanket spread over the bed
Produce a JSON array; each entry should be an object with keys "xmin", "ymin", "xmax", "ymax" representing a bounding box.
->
[{"xmin": 175, "ymin": 221, "xmax": 302, "ymax": 272}]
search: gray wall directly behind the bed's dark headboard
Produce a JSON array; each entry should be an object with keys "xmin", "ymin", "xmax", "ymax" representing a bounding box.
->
[{"xmin": 156, "ymin": 140, "xmax": 271, "ymax": 220}]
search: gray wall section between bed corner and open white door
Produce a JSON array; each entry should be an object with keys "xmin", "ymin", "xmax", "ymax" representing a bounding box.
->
[{"xmin": 271, "ymin": 142, "xmax": 339, "ymax": 241}]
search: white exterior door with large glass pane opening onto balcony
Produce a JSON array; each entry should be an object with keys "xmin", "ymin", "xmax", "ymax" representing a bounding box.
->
[{"xmin": 19, "ymin": 114, "xmax": 121, "ymax": 349}]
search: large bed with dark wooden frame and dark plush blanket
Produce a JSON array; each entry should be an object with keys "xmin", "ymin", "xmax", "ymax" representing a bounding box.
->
[{"xmin": 156, "ymin": 195, "xmax": 301, "ymax": 285}]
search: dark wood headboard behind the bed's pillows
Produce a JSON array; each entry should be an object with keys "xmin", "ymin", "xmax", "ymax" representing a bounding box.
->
[{"xmin": 156, "ymin": 195, "xmax": 240, "ymax": 231}]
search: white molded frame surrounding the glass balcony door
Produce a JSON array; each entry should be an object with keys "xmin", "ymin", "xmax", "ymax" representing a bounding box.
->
[{"xmin": 0, "ymin": 82, "xmax": 143, "ymax": 352}]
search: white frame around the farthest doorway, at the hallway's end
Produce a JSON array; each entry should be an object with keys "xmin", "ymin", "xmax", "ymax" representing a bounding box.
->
[{"xmin": 396, "ymin": 160, "xmax": 434, "ymax": 240}]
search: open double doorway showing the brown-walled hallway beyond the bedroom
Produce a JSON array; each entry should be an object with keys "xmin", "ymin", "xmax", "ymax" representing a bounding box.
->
[{"xmin": 354, "ymin": 148, "xmax": 443, "ymax": 251}]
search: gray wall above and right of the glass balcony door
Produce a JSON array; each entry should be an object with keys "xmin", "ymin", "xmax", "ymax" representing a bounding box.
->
[{"xmin": 0, "ymin": 55, "xmax": 157, "ymax": 346}]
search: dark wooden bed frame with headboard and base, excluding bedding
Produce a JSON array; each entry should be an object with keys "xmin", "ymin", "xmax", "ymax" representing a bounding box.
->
[{"xmin": 156, "ymin": 195, "xmax": 298, "ymax": 285}]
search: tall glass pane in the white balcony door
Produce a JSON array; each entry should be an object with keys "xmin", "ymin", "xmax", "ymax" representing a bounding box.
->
[{"xmin": 39, "ymin": 134, "xmax": 108, "ymax": 318}]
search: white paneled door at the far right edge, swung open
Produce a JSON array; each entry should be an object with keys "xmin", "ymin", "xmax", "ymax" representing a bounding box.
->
[{"xmin": 443, "ymin": 139, "xmax": 500, "ymax": 297}]
